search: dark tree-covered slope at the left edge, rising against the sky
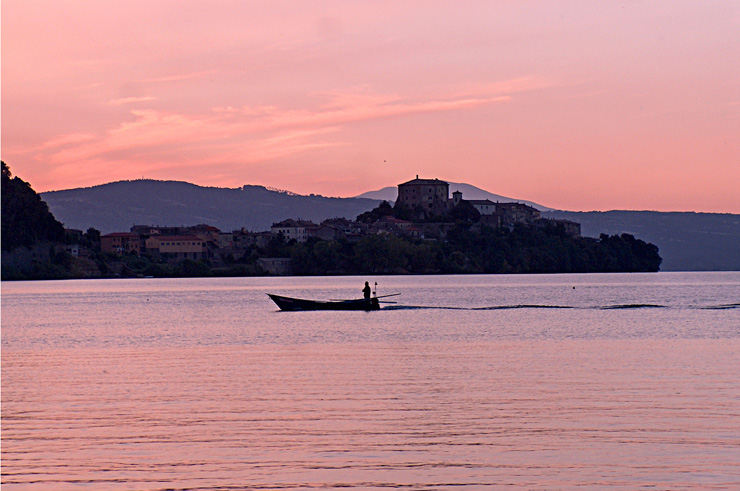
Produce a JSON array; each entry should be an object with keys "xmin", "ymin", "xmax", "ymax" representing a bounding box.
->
[{"xmin": 2, "ymin": 162, "xmax": 64, "ymax": 251}]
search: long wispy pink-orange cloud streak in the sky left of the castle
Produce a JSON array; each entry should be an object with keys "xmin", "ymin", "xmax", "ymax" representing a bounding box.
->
[{"xmin": 38, "ymin": 84, "xmax": 510, "ymax": 171}]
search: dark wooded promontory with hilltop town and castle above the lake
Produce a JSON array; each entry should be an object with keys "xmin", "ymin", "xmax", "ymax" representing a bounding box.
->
[{"xmin": 3, "ymin": 166, "xmax": 660, "ymax": 279}]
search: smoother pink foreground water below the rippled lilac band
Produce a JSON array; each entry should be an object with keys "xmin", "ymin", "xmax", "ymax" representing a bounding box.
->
[{"xmin": 2, "ymin": 340, "xmax": 740, "ymax": 490}]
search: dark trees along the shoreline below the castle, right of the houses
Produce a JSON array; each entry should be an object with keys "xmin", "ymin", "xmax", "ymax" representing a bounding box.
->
[{"xmin": 274, "ymin": 222, "xmax": 661, "ymax": 275}]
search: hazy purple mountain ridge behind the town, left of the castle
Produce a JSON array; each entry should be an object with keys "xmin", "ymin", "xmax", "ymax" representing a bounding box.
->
[{"xmin": 41, "ymin": 179, "xmax": 380, "ymax": 234}]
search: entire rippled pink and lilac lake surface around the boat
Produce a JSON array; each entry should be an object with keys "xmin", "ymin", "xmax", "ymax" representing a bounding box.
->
[{"xmin": 2, "ymin": 273, "xmax": 740, "ymax": 491}]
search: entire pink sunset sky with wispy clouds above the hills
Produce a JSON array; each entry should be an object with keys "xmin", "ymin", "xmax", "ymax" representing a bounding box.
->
[{"xmin": 2, "ymin": 0, "xmax": 740, "ymax": 213}]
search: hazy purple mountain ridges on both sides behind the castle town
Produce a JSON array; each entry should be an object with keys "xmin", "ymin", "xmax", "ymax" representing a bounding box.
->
[{"xmin": 41, "ymin": 179, "xmax": 740, "ymax": 271}]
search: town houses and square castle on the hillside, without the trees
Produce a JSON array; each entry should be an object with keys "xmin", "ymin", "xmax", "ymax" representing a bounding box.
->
[{"xmin": 100, "ymin": 176, "xmax": 580, "ymax": 270}]
